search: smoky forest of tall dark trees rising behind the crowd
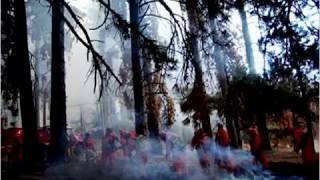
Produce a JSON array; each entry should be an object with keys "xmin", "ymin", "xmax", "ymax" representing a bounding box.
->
[{"xmin": 1, "ymin": 0, "xmax": 320, "ymax": 179}]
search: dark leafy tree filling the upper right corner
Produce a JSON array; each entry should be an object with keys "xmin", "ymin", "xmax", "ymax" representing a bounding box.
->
[{"xmin": 252, "ymin": 0, "xmax": 319, "ymax": 151}]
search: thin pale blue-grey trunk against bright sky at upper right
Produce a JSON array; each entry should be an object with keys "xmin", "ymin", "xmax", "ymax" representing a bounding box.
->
[{"xmin": 236, "ymin": 0, "xmax": 256, "ymax": 74}]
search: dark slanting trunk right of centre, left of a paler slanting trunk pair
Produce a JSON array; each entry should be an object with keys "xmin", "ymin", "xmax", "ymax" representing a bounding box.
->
[{"xmin": 186, "ymin": 0, "xmax": 212, "ymax": 137}]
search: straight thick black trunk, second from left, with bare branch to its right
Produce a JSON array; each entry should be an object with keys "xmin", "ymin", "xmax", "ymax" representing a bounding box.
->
[{"xmin": 50, "ymin": 0, "xmax": 67, "ymax": 162}]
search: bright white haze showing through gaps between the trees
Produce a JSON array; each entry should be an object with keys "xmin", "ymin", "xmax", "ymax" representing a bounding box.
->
[{"xmin": 66, "ymin": 0, "xmax": 263, "ymax": 131}]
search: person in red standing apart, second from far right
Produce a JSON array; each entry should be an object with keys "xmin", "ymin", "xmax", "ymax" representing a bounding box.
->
[{"xmin": 248, "ymin": 122, "xmax": 269, "ymax": 168}]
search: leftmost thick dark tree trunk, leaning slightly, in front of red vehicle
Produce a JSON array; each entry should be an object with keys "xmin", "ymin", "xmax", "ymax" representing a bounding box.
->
[{"xmin": 14, "ymin": 0, "xmax": 40, "ymax": 163}]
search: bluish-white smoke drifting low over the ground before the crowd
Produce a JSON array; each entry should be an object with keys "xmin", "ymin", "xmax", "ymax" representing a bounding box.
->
[{"xmin": 46, "ymin": 135, "xmax": 302, "ymax": 180}]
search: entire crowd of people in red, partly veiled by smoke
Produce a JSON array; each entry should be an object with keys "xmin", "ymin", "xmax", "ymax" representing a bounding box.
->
[{"xmin": 64, "ymin": 115, "xmax": 313, "ymax": 179}]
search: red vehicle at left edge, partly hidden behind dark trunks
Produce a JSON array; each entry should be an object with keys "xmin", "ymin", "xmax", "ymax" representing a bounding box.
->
[{"xmin": 1, "ymin": 128, "xmax": 49, "ymax": 161}]
